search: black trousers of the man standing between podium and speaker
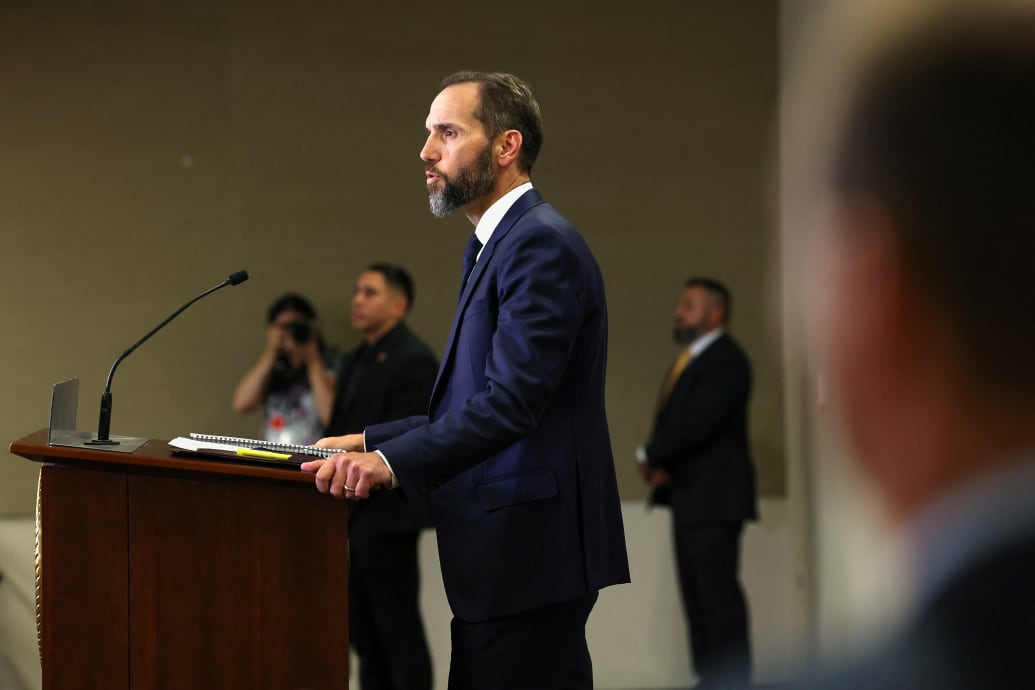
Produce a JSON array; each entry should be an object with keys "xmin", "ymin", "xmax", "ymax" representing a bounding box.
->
[{"xmin": 349, "ymin": 532, "xmax": 432, "ymax": 690}]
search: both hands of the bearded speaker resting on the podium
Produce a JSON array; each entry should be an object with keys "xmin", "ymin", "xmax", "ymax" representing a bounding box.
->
[{"xmin": 301, "ymin": 433, "xmax": 392, "ymax": 499}]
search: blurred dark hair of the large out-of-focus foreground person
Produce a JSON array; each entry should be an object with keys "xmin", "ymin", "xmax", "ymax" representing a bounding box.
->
[{"xmin": 834, "ymin": 7, "xmax": 1035, "ymax": 395}]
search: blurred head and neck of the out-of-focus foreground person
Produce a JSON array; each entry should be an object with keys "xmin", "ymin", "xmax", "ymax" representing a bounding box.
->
[{"xmin": 822, "ymin": 3, "xmax": 1035, "ymax": 517}]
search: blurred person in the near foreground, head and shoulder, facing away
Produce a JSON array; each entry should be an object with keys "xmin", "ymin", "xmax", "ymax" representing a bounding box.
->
[{"xmin": 786, "ymin": 2, "xmax": 1035, "ymax": 690}]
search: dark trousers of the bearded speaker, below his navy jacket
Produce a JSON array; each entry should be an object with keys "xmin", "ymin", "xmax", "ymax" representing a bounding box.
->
[{"xmin": 449, "ymin": 592, "xmax": 597, "ymax": 690}]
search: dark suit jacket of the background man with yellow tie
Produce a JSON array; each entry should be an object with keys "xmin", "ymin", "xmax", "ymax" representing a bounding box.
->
[{"xmin": 646, "ymin": 333, "xmax": 757, "ymax": 524}]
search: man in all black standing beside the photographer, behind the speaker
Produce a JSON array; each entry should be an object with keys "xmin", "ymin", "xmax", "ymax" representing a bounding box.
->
[{"xmin": 327, "ymin": 264, "xmax": 439, "ymax": 690}]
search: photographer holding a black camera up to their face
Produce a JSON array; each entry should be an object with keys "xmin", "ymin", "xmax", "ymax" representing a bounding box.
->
[{"xmin": 233, "ymin": 294, "xmax": 341, "ymax": 444}]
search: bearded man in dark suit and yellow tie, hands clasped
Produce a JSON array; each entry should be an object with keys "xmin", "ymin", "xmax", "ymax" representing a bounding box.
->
[{"xmin": 637, "ymin": 278, "xmax": 757, "ymax": 688}]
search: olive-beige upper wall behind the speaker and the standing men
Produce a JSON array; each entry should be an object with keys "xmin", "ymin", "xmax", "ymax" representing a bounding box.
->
[{"xmin": 0, "ymin": 0, "xmax": 785, "ymax": 513}]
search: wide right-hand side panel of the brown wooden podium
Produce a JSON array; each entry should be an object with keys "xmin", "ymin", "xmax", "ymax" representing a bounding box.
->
[{"xmin": 128, "ymin": 476, "xmax": 349, "ymax": 689}]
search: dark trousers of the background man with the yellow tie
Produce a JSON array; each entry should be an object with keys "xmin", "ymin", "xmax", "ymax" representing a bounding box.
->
[{"xmin": 674, "ymin": 522, "xmax": 751, "ymax": 688}]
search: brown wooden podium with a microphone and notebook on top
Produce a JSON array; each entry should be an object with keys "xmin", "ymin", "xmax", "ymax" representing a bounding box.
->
[{"xmin": 10, "ymin": 429, "xmax": 349, "ymax": 690}]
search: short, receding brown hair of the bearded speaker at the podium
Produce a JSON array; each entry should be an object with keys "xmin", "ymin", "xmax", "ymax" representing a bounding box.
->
[{"xmin": 440, "ymin": 71, "xmax": 542, "ymax": 173}]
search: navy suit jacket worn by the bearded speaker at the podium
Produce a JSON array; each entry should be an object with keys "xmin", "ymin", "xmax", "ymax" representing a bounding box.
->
[{"xmin": 365, "ymin": 189, "xmax": 629, "ymax": 622}]
